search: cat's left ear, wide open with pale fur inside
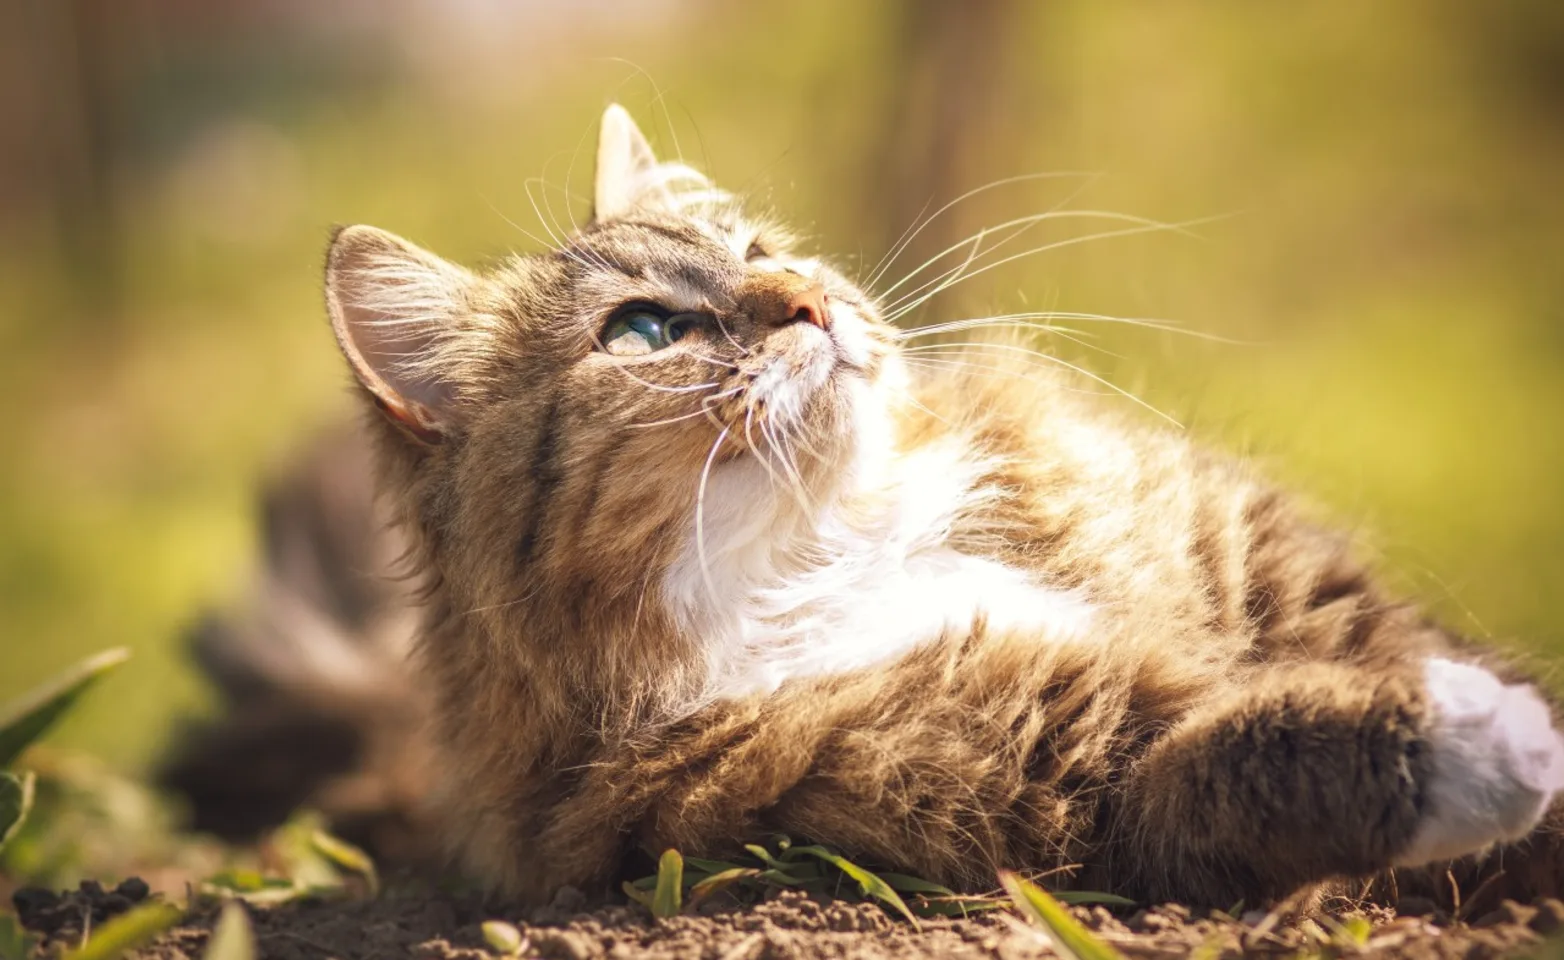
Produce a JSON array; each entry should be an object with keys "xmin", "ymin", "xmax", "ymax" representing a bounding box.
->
[{"xmin": 325, "ymin": 227, "xmax": 477, "ymax": 444}]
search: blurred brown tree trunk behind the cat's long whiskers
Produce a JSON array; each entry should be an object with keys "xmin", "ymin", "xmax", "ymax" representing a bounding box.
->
[{"xmin": 865, "ymin": 0, "xmax": 1024, "ymax": 322}]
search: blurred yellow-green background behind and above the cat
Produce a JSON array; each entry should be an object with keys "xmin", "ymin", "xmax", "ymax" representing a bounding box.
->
[{"xmin": 0, "ymin": 0, "xmax": 1564, "ymax": 771}]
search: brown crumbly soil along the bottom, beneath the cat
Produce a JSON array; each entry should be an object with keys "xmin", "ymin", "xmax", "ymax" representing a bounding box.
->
[{"xmin": 16, "ymin": 880, "xmax": 1564, "ymax": 960}]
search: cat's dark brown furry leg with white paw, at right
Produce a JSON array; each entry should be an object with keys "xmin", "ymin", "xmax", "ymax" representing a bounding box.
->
[{"xmin": 1125, "ymin": 658, "xmax": 1564, "ymax": 904}]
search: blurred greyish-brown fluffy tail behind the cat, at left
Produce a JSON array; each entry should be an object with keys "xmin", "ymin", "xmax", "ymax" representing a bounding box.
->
[{"xmin": 160, "ymin": 428, "xmax": 433, "ymax": 860}]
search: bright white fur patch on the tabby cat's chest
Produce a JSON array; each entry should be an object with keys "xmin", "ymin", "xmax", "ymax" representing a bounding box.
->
[{"xmin": 665, "ymin": 428, "xmax": 1092, "ymax": 702}]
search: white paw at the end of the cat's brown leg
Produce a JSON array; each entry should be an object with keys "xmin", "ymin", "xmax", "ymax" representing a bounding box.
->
[{"xmin": 1397, "ymin": 658, "xmax": 1564, "ymax": 866}]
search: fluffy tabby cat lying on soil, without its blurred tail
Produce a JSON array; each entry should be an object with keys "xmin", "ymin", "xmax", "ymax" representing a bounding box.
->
[{"xmin": 168, "ymin": 106, "xmax": 1564, "ymax": 905}]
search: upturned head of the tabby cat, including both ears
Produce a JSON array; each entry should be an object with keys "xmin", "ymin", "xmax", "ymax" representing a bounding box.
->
[{"xmin": 327, "ymin": 106, "xmax": 899, "ymax": 687}]
